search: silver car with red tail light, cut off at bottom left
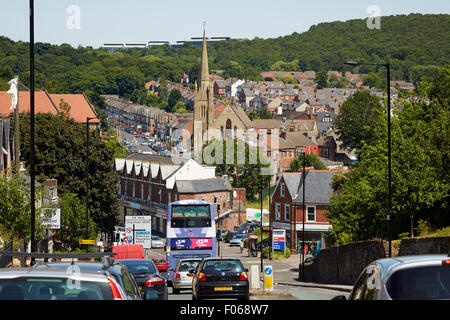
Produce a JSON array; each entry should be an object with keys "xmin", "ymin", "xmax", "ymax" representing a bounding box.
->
[{"xmin": 0, "ymin": 268, "xmax": 127, "ymax": 300}]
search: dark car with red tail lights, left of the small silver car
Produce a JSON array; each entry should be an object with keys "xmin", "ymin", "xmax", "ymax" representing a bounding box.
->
[{"xmin": 117, "ymin": 259, "xmax": 168, "ymax": 300}]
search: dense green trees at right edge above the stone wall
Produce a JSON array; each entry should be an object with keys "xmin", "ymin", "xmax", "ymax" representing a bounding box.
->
[{"xmin": 328, "ymin": 66, "xmax": 450, "ymax": 242}]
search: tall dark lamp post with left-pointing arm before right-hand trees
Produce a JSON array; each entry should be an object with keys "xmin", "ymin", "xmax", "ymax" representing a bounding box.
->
[{"xmin": 344, "ymin": 61, "xmax": 392, "ymax": 257}]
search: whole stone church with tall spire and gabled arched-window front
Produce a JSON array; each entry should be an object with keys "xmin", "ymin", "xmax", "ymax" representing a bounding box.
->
[{"xmin": 192, "ymin": 30, "xmax": 253, "ymax": 154}]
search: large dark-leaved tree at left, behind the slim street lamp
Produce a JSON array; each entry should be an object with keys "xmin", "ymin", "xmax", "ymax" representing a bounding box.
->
[{"xmin": 20, "ymin": 112, "xmax": 118, "ymax": 232}]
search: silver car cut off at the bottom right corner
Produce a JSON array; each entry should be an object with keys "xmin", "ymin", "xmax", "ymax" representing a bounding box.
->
[{"xmin": 334, "ymin": 255, "xmax": 450, "ymax": 300}]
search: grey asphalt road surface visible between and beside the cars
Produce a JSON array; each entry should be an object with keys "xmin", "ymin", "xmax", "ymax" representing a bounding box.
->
[{"xmin": 145, "ymin": 241, "xmax": 347, "ymax": 300}]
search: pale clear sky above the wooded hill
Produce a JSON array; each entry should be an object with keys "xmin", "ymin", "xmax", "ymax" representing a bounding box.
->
[{"xmin": 0, "ymin": 0, "xmax": 450, "ymax": 48}]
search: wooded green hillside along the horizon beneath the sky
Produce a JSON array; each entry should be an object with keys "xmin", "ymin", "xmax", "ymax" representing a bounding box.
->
[{"xmin": 0, "ymin": 14, "xmax": 450, "ymax": 97}]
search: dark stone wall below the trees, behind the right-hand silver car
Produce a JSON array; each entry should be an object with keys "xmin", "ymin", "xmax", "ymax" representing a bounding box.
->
[{"xmin": 300, "ymin": 237, "xmax": 450, "ymax": 285}]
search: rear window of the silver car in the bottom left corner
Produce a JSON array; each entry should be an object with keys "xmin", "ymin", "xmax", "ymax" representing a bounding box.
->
[{"xmin": 0, "ymin": 277, "xmax": 113, "ymax": 300}]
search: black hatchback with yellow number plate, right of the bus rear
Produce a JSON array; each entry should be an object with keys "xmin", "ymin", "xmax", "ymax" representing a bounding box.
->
[{"xmin": 192, "ymin": 258, "xmax": 249, "ymax": 300}]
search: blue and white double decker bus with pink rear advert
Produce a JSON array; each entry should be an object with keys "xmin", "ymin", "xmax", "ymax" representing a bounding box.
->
[{"xmin": 166, "ymin": 200, "xmax": 217, "ymax": 279}]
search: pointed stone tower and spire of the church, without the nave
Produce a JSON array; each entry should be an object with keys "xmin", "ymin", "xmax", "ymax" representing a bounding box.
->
[{"xmin": 193, "ymin": 30, "xmax": 214, "ymax": 154}]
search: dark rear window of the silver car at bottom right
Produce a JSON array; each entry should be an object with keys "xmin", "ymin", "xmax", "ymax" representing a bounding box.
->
[{"xmin": 387, "ymin": 266, "xmax": 450, "ymax": 300}]
